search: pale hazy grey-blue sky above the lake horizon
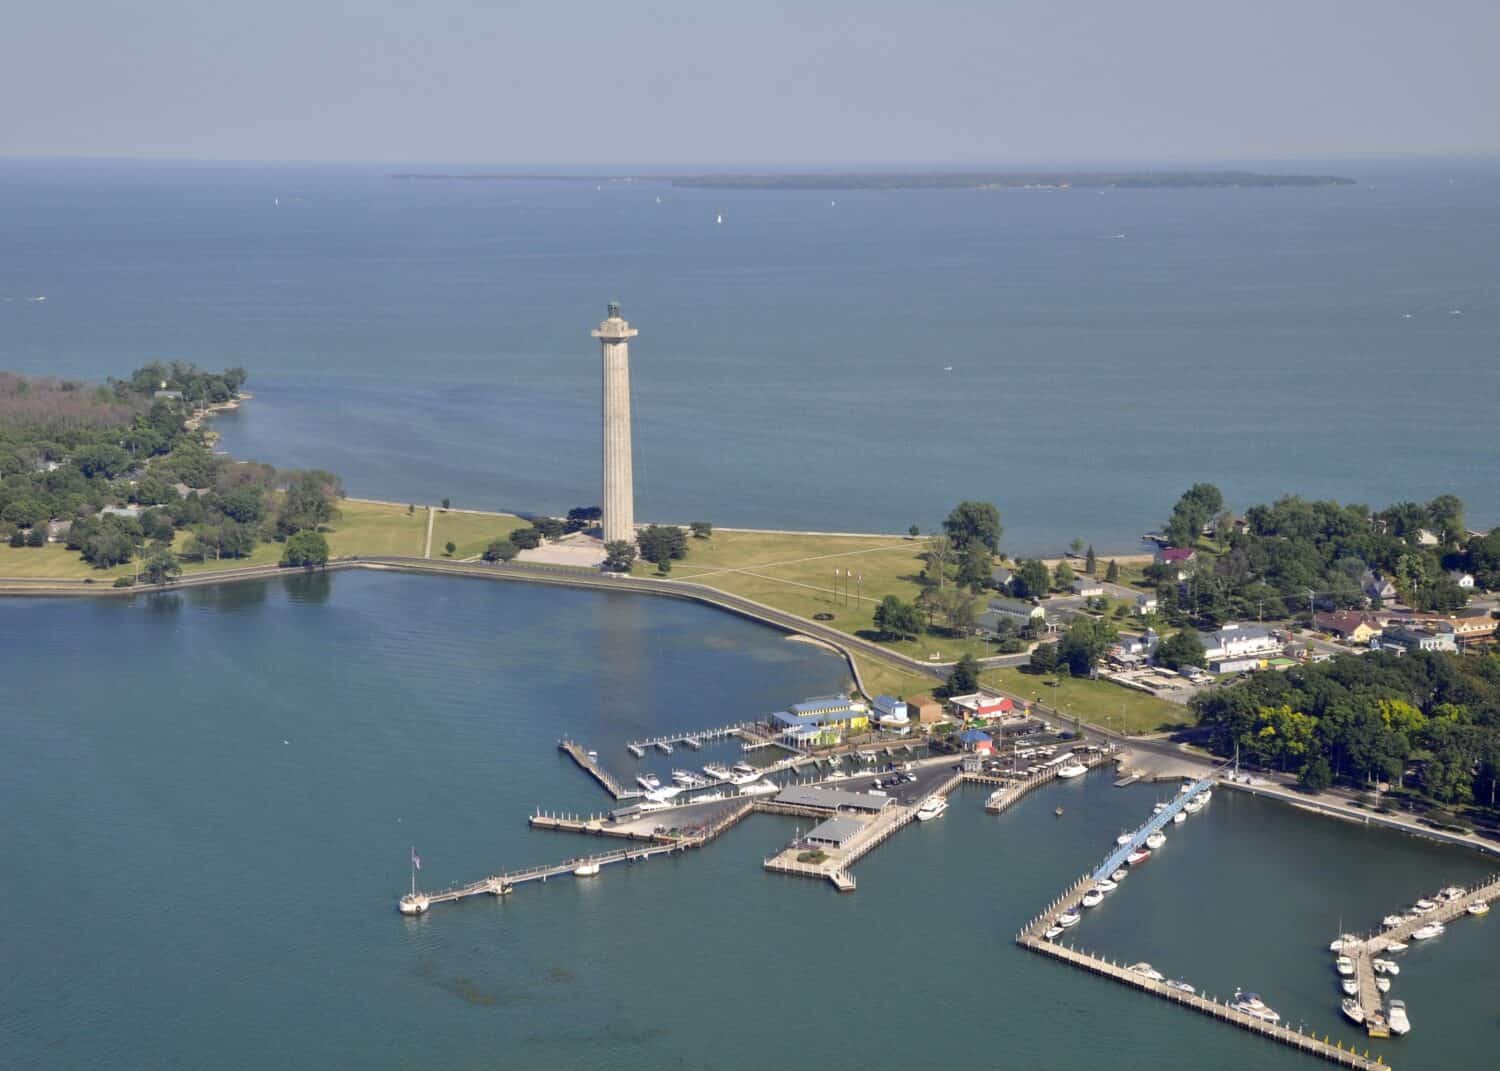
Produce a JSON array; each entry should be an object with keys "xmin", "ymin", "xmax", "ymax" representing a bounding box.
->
[{"xmin": 0, "ymin": 0, "xmax": 1500, "ymax": 167}]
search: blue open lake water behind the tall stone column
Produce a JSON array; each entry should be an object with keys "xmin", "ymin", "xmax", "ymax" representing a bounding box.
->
[{"xmin": 0, "ymin": 161, "xmax": 1500, "ymax": 552}]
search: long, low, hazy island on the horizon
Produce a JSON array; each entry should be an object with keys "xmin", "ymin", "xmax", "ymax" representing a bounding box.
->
[{"xmin": 392, "ymin": 171, "xmax": 1355, "ymax": 191}]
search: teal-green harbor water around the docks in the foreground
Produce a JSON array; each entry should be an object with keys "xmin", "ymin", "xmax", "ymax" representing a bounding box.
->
[{"xmin": 0, "ymin": 575, "xmax": 1500, "ymax": 1071}]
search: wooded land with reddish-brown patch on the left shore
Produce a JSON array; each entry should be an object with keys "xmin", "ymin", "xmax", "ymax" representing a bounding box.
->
[{"xmin": 0, "ymin": 362, "xmax": 344, "ymax": 587}]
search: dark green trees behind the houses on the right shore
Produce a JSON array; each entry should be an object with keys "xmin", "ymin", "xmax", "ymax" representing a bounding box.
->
[{"xmin": 1148, "ymin": 483, "xmax": 1476, "ymax": 627}]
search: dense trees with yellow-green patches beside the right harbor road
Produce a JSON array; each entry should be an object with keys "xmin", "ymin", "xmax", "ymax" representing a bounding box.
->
[{"xmin": 1194, "ymin": 651, "xmax": 1500, "ymax": 807}]
